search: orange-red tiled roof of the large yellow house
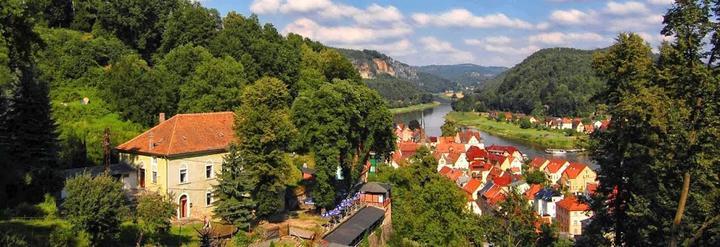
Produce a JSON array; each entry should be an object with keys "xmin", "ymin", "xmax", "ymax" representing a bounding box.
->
[{"xmin": 116, "ymin": 112, "xmax": 235, "ymax": 156}]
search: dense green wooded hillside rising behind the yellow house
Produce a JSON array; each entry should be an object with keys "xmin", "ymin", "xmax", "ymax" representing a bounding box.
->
[{"xmin": 0, "ymin": 0, "xmax": 361, "ymax": 170}]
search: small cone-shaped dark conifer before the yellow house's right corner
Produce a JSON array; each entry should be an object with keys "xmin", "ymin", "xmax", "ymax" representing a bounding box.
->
[{"xmin": 213, "ymin": 144, "xmax": 257, "ymax": 231}]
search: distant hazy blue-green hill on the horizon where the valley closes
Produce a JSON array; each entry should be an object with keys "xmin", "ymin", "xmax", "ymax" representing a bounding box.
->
[{"xmin": 416, "ymin": 63, "xmax": 508, "ymax": 87}]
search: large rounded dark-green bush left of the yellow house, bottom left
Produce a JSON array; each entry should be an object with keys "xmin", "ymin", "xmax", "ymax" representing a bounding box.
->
[{"xmin": 63, "ymin": 173, "xmax": 126, "ymax": 244}]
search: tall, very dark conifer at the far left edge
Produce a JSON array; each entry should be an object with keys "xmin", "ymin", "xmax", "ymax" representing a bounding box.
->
[{"xmin": 0, "ymin": 0, "xmax": 58, "ymax": 205}]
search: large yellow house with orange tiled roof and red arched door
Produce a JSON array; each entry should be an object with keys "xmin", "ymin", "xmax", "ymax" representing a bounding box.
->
[{"xmin": 116, "ymin": 112, "xmax": 235, "ymax": 219}]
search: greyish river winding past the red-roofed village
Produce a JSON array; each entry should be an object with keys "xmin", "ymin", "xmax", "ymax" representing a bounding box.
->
[{"xmin": 395, "ymin": 103, "xmax": 597, "ymax": 165}]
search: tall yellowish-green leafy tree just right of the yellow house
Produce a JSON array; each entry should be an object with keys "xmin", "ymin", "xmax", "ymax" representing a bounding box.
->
[{"xmin": 235, "ymin": 77, "xmax": 295, "ymax": 217}]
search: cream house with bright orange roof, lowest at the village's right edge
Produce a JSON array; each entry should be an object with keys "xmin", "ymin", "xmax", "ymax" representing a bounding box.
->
[{"xmin": 556, "ymin": 196, "xmax": 592, "ymax": 236}]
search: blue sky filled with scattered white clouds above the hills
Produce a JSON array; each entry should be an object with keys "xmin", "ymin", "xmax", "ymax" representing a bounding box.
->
[{"xmin": 201, "ymin": 0, "xmax": 673, "ymax": 67}]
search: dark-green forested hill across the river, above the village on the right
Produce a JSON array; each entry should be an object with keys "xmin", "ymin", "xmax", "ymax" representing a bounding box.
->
[{"xmin": 455, "ymin": 48, "xmax": 603, "ymax": 116}]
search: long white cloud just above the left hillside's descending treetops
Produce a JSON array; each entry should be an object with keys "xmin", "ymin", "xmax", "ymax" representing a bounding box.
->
[{"xmin": 283, "ymin": 18, "xmax": 412, "ymax": 44}]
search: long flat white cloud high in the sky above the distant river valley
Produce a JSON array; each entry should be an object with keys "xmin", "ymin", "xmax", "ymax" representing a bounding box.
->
[{"xmin": 412, "ymin": 9, "xmax": 537, "ymax": 29}]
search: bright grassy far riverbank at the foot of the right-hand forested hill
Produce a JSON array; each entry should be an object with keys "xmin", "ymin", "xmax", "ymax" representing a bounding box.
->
[{"xmin": 445, "ymin": 112, "xmax": 587, "ymax": 149}]
